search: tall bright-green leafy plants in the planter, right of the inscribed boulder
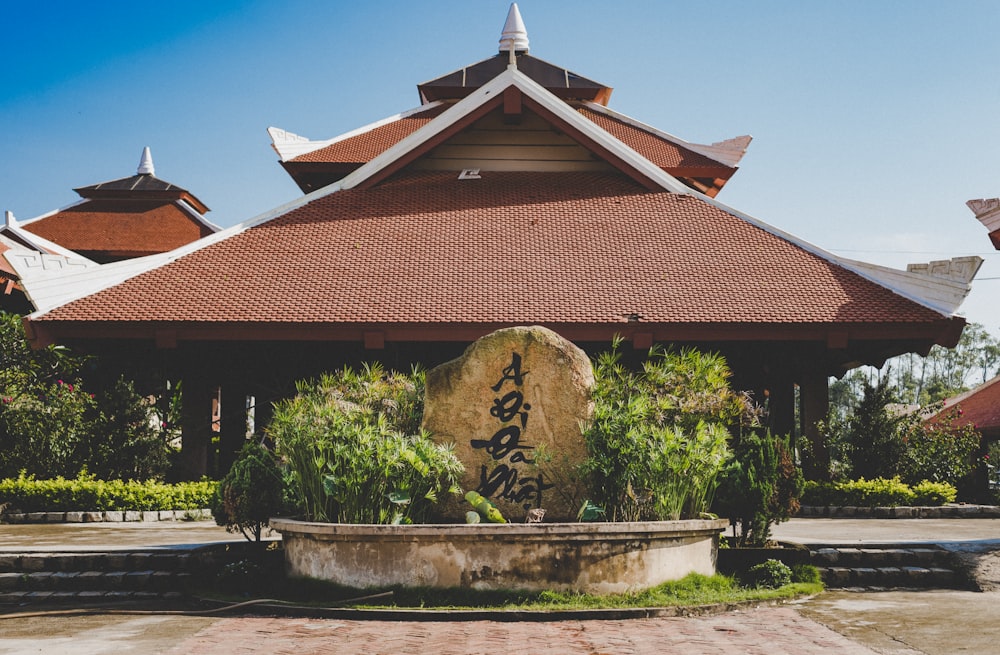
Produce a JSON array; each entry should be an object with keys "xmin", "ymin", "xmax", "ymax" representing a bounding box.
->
[{"xmin": 581, "ymin": 340, "xmax": 746, "ymax": 521}]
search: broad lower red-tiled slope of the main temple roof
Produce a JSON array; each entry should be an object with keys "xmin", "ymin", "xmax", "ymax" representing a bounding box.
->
[{"xmin": 37, "ymin": 172, "xmax": 944, "ymax": 325}]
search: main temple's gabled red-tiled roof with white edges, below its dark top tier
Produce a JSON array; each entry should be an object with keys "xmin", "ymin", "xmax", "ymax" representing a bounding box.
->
[{"xmin": 11, "ymin": 6, "xmax": 977, "ymax": 375}]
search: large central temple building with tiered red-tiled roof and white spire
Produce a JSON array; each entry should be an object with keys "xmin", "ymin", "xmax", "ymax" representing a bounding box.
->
[{"xmin": 5, "ymin": 5, "xmax": 981, "ymax": 476}]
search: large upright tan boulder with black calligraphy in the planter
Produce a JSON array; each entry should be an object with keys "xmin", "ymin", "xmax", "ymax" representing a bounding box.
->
[{"xmin": 423, "ymin": 326, "xmax": 594, "ymax": 522}]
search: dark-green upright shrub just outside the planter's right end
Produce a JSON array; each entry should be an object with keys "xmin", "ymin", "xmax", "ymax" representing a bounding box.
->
[{"xmin": 714, "ymin": 432, "xmax": 804, "ymax": 547}]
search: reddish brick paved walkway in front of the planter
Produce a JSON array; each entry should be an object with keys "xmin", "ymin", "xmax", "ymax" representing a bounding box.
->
[{"xmin": 162, "ymin": 607, "xmax": 875, "ymax": 655}]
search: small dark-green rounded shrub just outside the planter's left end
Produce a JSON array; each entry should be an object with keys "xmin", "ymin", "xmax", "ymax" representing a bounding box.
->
[{"xmin": 212, "ymin": 442, "xmax": 285, "ymax": 543}]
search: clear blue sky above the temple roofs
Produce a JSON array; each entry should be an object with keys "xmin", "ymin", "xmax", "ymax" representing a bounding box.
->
[{"xmin": 0, "ymin": 0, "xmax": 1000, "ymax": 334}]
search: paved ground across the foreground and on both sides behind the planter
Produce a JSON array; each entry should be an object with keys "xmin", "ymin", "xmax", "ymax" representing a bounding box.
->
[{"xmin": 0, "ymin": 519, "xmax": 1000, "ymax": 655}]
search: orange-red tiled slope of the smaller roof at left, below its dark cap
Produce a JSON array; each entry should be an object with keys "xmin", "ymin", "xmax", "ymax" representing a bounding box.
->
[{"xmin": 22, "ymin": 198, "xmax": 212, "ymax": 256}]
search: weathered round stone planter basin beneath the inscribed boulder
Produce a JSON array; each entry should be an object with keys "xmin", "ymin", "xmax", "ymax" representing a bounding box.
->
[{"xmin": 271, "ymin": 518, "xmax": 729, "ymax": 594}]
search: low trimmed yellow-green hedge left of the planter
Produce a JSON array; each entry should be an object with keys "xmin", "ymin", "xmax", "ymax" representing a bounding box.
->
[{"xmin": 0, "ymin": 475, "xmax": 218, "ymax": 512}]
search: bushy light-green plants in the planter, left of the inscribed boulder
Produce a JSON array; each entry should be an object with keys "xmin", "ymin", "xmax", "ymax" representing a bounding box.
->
[{"xmin": 267, "ymin": 365, "xmax": 463, "ymax": 523}]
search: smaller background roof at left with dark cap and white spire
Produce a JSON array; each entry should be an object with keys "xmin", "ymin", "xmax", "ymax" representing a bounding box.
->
[{"xmin": 18, "ymin": 148, "xmax": 218, "ymax": 262}]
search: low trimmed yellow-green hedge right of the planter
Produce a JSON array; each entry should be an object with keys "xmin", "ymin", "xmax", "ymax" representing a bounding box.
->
[{"xmin": 802, "ymin": 477, "xmax": 958, "ymax": 507}]
